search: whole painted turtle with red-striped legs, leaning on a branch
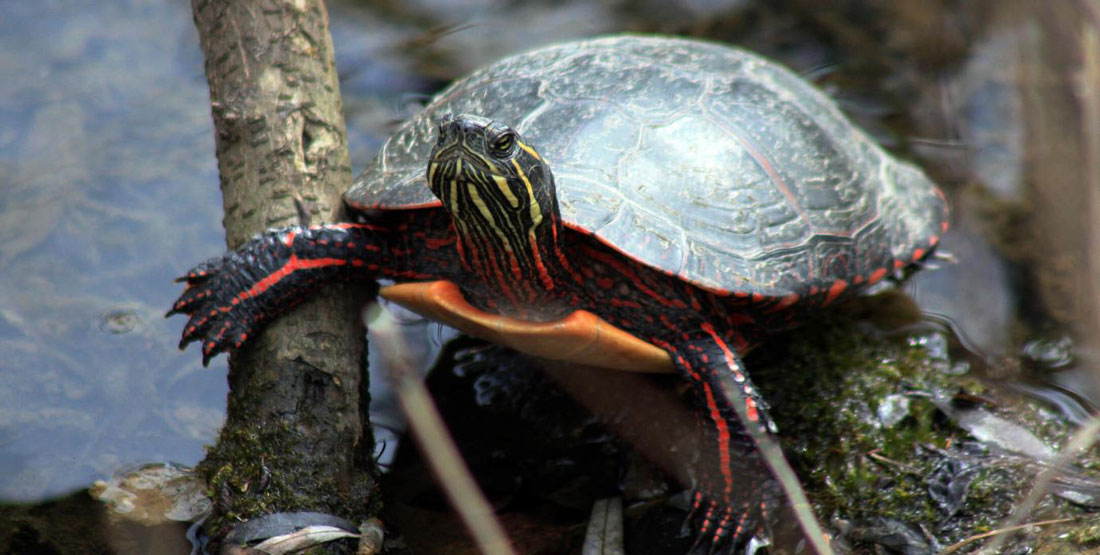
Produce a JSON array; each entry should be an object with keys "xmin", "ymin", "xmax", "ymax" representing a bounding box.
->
[{"xmin": 173, "ymin": 36, "xmax": 947, "ymax": 547}]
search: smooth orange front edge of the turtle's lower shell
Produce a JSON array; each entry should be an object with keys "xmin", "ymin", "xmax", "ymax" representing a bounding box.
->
[{"xmin": 380, "ymin": 281, "xmax": 674, "ymax": 374}]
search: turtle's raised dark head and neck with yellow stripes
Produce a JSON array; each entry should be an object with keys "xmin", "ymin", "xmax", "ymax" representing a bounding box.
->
[{"xmin": 428, "ymin": 114, "xmax": 562, "ymax": 312}]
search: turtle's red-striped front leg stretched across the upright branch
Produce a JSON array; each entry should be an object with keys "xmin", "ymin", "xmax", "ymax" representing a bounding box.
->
[{"xmin": 168, "ymin": 211, "xmax": 454, "ymax": 365}]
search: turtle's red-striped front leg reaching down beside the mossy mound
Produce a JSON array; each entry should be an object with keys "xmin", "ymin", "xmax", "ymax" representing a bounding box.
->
[{"xmin": 664, "ymin": 334, "xmax": 782, "ymax": 553}]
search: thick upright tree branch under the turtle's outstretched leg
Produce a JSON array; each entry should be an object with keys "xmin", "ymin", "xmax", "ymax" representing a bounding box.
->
[{"xmin": 193, "ymin": 0, "xmax": 377, "ymax": 547}]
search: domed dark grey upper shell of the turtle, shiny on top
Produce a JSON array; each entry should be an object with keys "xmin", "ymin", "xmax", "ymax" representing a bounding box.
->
[{"xmin": 345, "ymin": 35, "xmax": 946, "ymax": 297}]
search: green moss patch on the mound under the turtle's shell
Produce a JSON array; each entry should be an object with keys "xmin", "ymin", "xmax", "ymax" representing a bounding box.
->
[{"xmin": 748, "ymin": 312, "xmax": 1096, "ymax": 547}]
